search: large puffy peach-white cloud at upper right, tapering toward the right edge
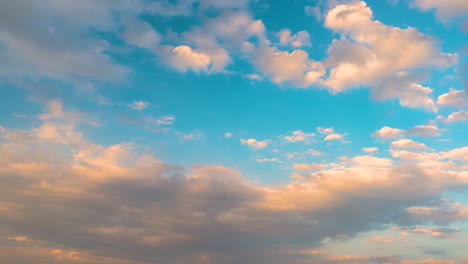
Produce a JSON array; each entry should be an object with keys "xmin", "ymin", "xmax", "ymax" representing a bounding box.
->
[{"xmin": 323, "ymin": 1, "xmax": 457, "ymax": 111}]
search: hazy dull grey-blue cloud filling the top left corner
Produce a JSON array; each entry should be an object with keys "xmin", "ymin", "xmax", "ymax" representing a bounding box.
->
[{"xmin": 0, "ymin": 0, "xmax": 133, "ymax": 83}]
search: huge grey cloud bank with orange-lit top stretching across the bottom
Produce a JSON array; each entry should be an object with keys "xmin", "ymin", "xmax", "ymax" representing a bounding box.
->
[{"xmin": 0, "ymin": 119, "xmax": 468, "ymax": 264}]
